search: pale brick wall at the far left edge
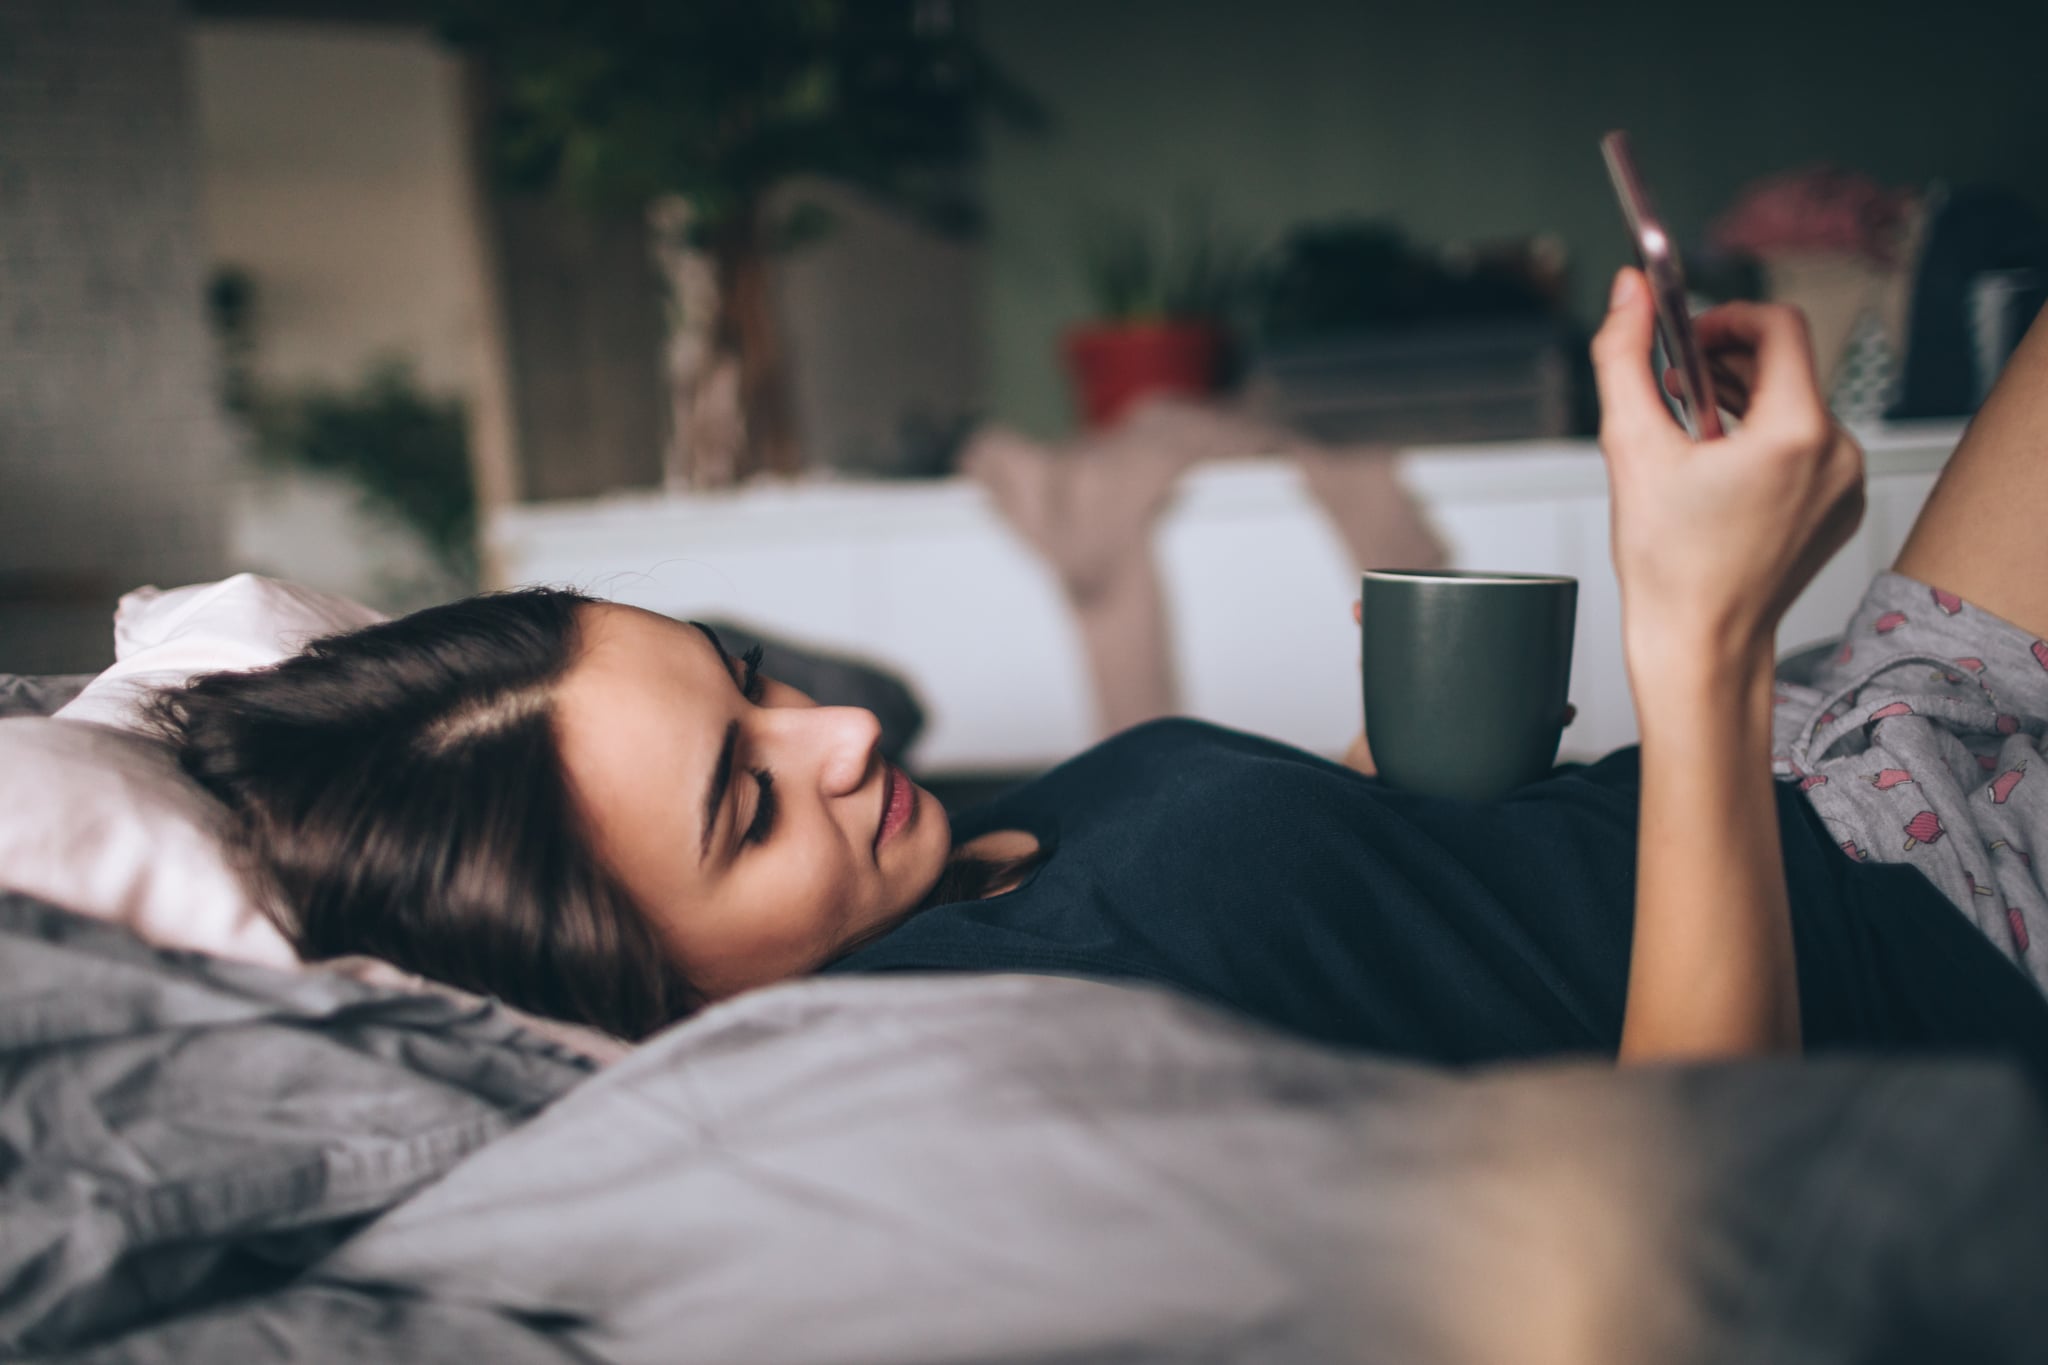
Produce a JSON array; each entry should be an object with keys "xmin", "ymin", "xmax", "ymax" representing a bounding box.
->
[{"xmin": 0, "ymin": 0, "xmax": 227, "ymax": 671}]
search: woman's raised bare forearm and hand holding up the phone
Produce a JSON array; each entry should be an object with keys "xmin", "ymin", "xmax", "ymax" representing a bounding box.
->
[{"xmin": 1593, "ymin": 270, "xmax": 1864, "ymax": 1062}]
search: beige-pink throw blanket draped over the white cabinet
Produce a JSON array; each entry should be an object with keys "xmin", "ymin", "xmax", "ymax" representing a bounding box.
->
[{"xmin": 961, "ymin": 399, "xmax": 1444, "ymax": 735}]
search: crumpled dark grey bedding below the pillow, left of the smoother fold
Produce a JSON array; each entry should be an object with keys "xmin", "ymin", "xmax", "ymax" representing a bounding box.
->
[{"xmin": 0, "ymin": 894, "xmax": 596, "ymax": 1359}]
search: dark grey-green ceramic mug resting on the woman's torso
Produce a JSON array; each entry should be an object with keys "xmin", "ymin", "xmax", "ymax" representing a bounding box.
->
[{"xmin": 1358, "ymin": 569, "xmax": 1579, "ymax": 800}]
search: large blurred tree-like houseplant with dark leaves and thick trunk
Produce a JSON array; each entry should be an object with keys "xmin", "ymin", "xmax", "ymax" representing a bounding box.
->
[{"xmin": 442, "ymin": 0, "xmax": 1040, "ymax": 483}]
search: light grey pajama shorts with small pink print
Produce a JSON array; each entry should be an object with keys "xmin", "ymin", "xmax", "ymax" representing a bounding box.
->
[{"xmin": 1772, "ymin": 573, "xmax": 2048, "ymax": 990}]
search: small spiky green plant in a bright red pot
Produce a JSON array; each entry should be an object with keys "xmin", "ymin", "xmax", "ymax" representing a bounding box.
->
[{"xmin": 1061, "ymin": 213, "xmax": 1245, "ymax": 428}]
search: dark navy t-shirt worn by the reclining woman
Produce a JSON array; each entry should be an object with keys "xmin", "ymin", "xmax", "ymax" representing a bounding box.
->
[{"xmin": 825, "ymin": 720, "xmax": 2048, "ymax": 1074}]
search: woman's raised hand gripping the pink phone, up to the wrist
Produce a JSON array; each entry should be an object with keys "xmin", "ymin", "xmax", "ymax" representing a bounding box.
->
[{"xmin": 1593, "ymin": 270, "xmax": 1864, "ymax": 690}]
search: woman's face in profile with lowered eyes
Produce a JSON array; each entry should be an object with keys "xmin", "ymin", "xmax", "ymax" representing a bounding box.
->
[{"xmin": 555, "ymin": 604, "xmax": 952, "ymax": 999}]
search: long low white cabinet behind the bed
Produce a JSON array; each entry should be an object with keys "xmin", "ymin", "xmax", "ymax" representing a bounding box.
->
[{"xmin": 489, "ymin": 424, "xmax": 1960, "ymax": 774}]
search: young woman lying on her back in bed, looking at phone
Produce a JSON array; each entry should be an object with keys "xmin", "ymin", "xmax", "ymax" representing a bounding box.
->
[{"xmin": 158, "ymin": 270, "xmax": 2048, "ymax": 1072}]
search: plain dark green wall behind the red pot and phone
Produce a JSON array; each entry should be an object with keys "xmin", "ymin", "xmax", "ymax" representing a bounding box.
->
[{"xmin": 977, "ymin": 0, "xmax": 2048, "ymax": 434}]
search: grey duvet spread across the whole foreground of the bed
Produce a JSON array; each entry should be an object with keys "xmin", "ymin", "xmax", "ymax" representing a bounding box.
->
[{"xmin": 0, "ymin": 896, "xmax": 2048, "ymax": 1365}]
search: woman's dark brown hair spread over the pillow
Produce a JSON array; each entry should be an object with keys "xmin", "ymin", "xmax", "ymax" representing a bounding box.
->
[{"xmin": 152, "ymin": 589, "xmax": 702, "ymax": 1038}]
